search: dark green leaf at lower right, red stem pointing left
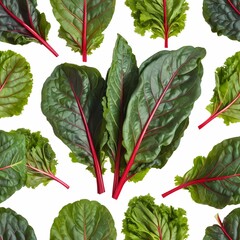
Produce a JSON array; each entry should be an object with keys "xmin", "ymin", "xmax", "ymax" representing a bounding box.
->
[{"xmin": 162, "ymin": 137, "xmax": 240, "ymax": 208}]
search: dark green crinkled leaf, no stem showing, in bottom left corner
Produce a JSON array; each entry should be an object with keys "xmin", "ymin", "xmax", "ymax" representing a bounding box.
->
[{"xmin": 0, "ymin": 208, "xmax": 37, "ymax": 240}]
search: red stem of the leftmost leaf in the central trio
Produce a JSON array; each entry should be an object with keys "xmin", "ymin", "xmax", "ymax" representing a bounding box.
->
[{"xmin": 70, "ymin": 83, "xmax": 105, "ymax": 194}]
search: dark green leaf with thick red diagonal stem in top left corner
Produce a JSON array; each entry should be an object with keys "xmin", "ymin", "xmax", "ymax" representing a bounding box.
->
[{"xmin": 0, "ymin": 0, "xmax": 58, "ymax": 56}]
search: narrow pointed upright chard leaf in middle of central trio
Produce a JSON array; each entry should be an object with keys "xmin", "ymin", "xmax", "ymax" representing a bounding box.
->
[{"xmin": 104, "ymin": 35, "xmax": 139, "ymax": 189}]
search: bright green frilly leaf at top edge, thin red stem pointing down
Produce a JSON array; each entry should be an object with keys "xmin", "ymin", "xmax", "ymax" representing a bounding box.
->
[{"xmin": 125, "ymin": 0, "xmax": 188, "ymax": 47}]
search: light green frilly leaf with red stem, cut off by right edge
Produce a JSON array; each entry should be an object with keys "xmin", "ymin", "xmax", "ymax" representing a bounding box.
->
[{"xmin": 199, "ymin": 52, "xmax": 240, "ymax": 129}]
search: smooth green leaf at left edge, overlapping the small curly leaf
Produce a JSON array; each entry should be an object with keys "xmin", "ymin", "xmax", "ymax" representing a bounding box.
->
[{"xmin": 0, "ymin": 131, "xmax": 26, "ymax": 203}]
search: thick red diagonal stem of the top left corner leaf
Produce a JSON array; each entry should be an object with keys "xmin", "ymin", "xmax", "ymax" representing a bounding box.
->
[{"xmin": 0, "ymin": 0, "xmax": 58, "ymax": 57}]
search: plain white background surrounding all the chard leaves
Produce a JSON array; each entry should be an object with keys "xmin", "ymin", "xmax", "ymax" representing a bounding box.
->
[{"xmin": 0, "ymin": 0, "xmax": 240, "ymax": 240}]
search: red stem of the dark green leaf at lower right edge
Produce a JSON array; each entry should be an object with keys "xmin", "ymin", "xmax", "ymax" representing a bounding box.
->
[{"xmin": 162, "ymin": 174, "xmax": 240, "ymax": 198}]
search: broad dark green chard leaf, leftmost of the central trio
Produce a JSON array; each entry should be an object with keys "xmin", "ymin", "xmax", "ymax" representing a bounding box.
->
[{"xmin": 42, "ymin": 63, "xmax": 106, "ymax": 193}]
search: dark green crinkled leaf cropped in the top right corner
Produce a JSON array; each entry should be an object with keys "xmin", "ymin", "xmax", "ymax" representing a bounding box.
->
[{"xmin": 203, "ymin": 0, "xmax": 240, "ymax": 41}]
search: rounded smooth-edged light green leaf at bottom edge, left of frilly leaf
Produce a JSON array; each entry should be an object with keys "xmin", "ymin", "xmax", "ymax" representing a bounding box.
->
[{"xmin": 50, "ymin": 199, "xmax": 117, "ymax": 240}]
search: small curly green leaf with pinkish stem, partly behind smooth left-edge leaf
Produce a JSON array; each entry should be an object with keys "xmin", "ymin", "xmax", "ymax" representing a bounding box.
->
[{"xmin": 12, "ymin": 128, "xmax": 69, "ymax": 188}]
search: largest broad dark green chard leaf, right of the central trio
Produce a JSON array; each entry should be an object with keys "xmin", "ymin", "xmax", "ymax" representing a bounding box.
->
[{"xmin": 114, "ymin": 46, "xmax": 205, "ymax": 197}]
